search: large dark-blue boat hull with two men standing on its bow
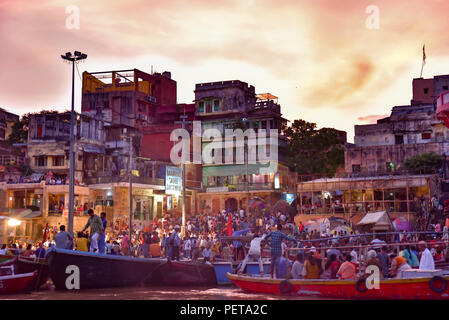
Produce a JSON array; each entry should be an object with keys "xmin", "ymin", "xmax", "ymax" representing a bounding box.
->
[{"xmin": 47, "ymin": 248, "xmax": 166, "ymax": 290}]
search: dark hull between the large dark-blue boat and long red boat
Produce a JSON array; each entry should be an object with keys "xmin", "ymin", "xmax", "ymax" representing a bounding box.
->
[{"xmin": 145, "ymin": 261, "xmax": 217, "ymax": 286}]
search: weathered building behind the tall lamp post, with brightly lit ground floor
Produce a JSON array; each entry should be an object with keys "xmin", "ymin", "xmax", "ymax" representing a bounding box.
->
[{"xmin": 0, "ymin": 112, "xmax": 104, "ymax": 238}]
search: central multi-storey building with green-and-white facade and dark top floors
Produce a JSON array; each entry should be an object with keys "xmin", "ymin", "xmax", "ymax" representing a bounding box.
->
[{"xmin": 195, "ymin": 80, "xmax": 294, "ymax": 212}]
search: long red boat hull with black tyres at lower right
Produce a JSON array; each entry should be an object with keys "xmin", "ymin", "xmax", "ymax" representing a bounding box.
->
[{"xmin": 226, "ymin": 273, "xmax": 449, "ymax": 300}]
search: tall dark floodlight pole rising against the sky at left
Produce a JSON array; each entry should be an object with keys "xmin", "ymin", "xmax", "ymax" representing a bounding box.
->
[{"xmin": 61, "ymin": 51, "xmax": 87, "ymax": 234}]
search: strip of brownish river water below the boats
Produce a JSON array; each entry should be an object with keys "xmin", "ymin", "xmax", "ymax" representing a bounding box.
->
[{"xmin": 0, "ymin": 284, "xmax": 324, "ymax": 300}]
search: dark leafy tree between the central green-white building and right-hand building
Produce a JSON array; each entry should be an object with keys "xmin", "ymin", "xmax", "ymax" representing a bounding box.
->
[{"xmin": 283, "ymin": 119, "xmax": 345, "ymax": 176}]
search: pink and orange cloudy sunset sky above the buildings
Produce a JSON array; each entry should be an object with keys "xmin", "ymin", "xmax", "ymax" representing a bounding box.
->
[{"xmin": 0, "ymin": 0, "xmax": 449, "ymax": 141}]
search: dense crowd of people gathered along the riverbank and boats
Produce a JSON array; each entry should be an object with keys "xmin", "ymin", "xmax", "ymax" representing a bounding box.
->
[{"xmin": 0, "ymin": 209, "xmax": 449, "ymax": 279}]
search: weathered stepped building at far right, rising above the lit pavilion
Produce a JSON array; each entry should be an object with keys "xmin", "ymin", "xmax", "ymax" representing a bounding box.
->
[{"xmin": 345, "ymin": 75, "xmax": 449, "ymax": 175}]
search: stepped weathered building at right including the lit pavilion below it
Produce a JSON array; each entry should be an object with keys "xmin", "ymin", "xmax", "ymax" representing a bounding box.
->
[{"xmin": 297, "ymin": 75, "xmax": 449, "ymax": 227}]
